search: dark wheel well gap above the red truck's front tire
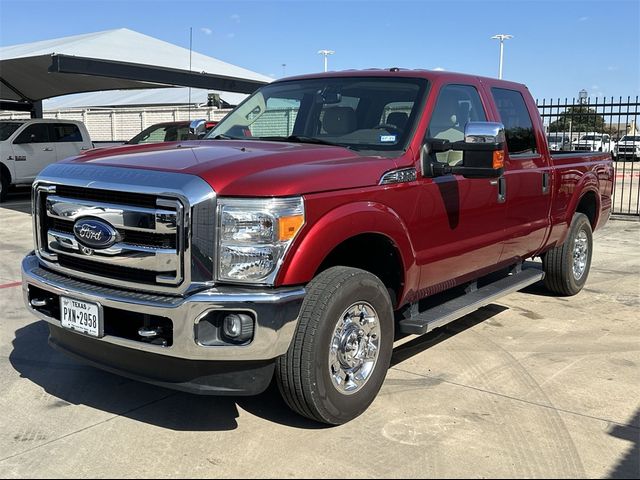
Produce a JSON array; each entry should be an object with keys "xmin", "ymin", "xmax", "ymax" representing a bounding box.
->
[{"xmin": 316, "ymin": 233, "xmax": 404, "ymax": 306}]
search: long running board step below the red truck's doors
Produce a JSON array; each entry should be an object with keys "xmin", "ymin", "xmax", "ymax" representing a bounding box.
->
[{"xmin": 398, "ymin": 268, "xmax": 544, "ymax": 335}]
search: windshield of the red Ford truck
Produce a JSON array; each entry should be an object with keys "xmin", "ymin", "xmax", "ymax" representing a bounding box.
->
[{"xmin": 206, "ymin": 77, "xmax": 427, "ymax": 152}]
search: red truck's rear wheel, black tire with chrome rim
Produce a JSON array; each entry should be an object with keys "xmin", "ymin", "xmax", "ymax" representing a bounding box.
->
[{"xmin": 542, "ymin": 213, "xmax": 593, "ymax": 296}]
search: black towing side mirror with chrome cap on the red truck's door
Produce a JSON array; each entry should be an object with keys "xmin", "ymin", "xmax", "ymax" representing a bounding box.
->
[{"xmin": 421, "ymin": 122, "xmax": 506, "ymax": 178}]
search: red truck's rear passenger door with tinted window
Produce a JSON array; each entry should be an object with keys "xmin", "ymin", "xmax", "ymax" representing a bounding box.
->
[{"xmin": 491, "ymin": 87, "xmax": 553, "ymax": 262}]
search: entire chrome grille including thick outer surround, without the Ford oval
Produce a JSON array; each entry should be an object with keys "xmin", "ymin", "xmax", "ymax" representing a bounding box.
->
[{"xmin": 33, "ymin": 166, "xmax": 215, "ymax": 293}]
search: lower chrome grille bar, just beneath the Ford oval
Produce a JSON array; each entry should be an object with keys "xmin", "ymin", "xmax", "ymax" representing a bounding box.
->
[{"xmin": 47, "ymin": 230, "xmax": 180, "ymax": 274}]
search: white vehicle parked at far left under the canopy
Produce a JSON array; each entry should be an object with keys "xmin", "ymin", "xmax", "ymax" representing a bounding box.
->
[{"xmin": 0, "ymin": 118, "xmax": 93, "ymax": 202}]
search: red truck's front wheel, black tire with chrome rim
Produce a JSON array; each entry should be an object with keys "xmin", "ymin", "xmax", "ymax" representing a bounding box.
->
[{"xmin": 276, "ymin": 267, "xmax": 394, "ymax": 425}]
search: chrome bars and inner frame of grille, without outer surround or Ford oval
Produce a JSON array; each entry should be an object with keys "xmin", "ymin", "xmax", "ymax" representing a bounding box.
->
[{"xmin": 40, "ymin": 187, "xmax": 185, "ymax": 285}]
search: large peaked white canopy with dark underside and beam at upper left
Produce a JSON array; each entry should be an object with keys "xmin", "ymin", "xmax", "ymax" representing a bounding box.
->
[{"xmin": 0, "ymin": 28, "xmax": 272, "ymax": 110}]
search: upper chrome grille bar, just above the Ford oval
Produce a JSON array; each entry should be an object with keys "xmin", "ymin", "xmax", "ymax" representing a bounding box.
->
[{"xmin": 46, "ymin": 195, "xmax": 177, "ymax": 233}]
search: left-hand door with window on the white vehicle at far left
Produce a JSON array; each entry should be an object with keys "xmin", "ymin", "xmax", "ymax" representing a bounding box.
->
[{"xmin": 11, "ymin": 123, "xmax": 57, "ymax": 183}]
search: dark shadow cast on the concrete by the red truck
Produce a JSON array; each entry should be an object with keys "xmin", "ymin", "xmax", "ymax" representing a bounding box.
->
[{"xmin": 9, "ymin": 304, "xmax": 506, "ymax": 431}]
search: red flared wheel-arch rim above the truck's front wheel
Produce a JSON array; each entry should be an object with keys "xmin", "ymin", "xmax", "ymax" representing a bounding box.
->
[{"xmin": 276, "ymin": 202, "xmax": 419, "ymax": 292}]
